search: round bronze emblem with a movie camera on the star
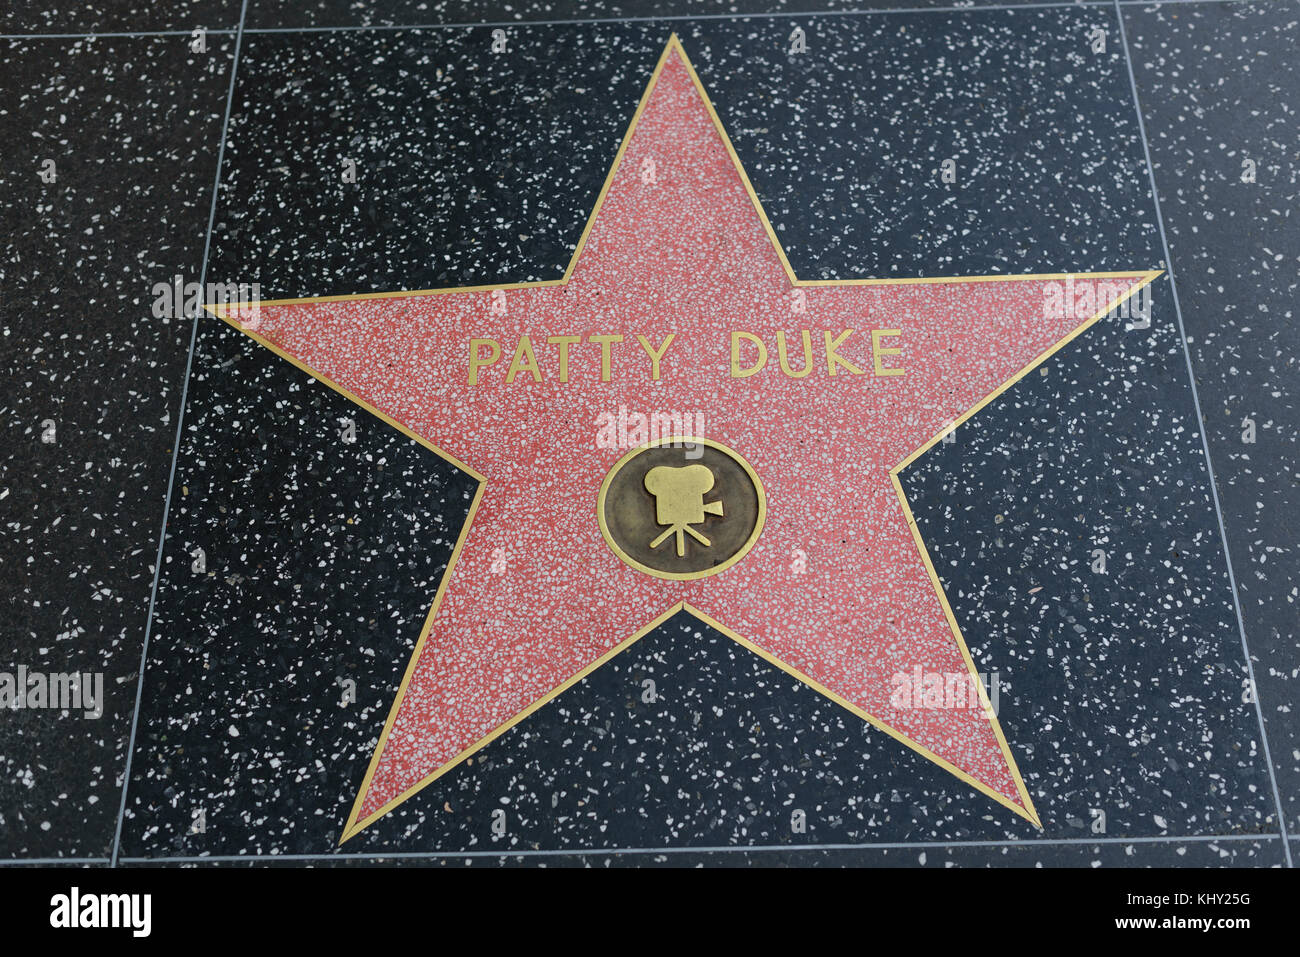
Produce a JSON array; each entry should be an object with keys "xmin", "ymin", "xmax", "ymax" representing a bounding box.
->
[{"xmin": 597, "ymin": 436, "xmax": 767, "ymax": 580}]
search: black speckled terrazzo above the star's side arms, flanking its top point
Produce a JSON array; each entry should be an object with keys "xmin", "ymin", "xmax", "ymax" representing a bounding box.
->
[{"xmin": 213, "ymin": 9, "xmax": 1161, "ymax": 298}]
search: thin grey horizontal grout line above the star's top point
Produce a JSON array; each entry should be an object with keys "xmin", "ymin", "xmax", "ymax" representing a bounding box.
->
[{"xmin": 0, "ymin": 0, "xmax": 1278, "ymax": 40}]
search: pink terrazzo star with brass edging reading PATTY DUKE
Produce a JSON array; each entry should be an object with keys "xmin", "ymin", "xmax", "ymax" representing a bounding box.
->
[{"xmin": 209, "ymin": 36, "xmax": 1158, "ymax": 840}]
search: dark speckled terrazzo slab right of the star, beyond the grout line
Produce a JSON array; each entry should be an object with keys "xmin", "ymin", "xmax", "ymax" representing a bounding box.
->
[{"xmin": 1126, "ymin": 3, "xmax": 1300, "ymax": 835}]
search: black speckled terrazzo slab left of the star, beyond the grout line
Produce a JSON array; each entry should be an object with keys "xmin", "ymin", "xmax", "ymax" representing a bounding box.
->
[{"xmin": 0, "ymin": 38, "xmax": 233, "ymax": 857}]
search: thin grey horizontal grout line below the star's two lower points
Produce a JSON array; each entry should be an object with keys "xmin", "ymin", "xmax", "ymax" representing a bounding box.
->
[{"xmin": 111, "ymin": 833, "xmax": 1279, "ymax": 863}]
